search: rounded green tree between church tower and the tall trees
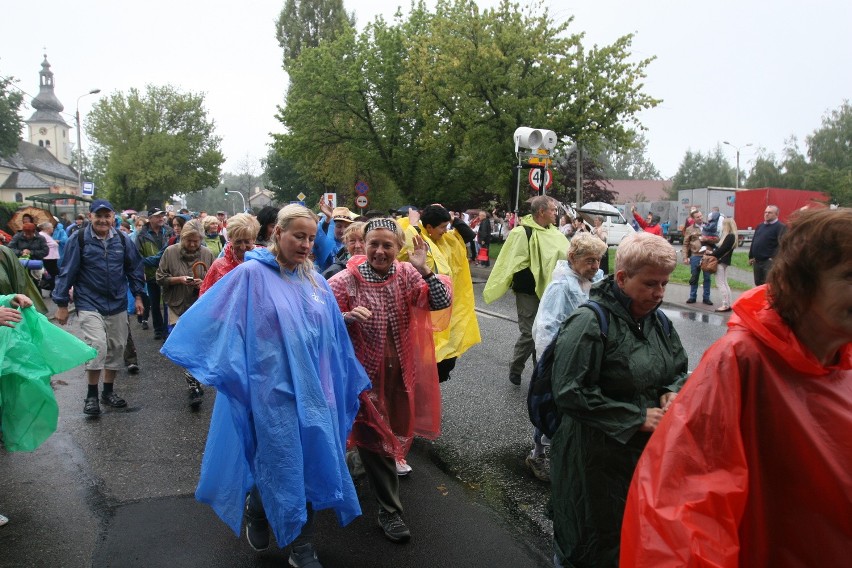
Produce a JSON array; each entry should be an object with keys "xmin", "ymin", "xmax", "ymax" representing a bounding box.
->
[{"xmin": 86, "ymin": 85, "xmax": 225, "ymax": 208}]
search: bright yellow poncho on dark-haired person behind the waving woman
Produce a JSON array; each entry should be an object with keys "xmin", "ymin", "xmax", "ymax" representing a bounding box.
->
[{"xmin": 397, "ymin": 218, "xmax": 482, "ymax": 361}]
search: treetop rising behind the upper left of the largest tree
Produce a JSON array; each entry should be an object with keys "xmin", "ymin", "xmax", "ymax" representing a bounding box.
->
[{"xmin": 275, "ymin": 0, "xmax": 355, "ymax": 69}]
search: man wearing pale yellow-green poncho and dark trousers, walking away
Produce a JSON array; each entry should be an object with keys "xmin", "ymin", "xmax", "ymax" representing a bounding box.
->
[{"xmin": 482, "ymin": 195, "xmax": 569, "ymax": 385}]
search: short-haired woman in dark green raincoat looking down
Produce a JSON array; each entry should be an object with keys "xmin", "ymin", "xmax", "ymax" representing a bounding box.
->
[{"xmin": 551, "ymin": 233, "xmax": 687, "ymax": 568}]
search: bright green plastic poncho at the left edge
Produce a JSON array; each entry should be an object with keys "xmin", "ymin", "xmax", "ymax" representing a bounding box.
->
[{"xmin": 0, "ymin": 302, "xmax": 98, "ymax": 452}]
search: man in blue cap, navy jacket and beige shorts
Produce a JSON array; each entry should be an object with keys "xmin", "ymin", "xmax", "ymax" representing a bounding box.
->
[{"xmin": 52, "ymin": 199, "xmax": 145, "ymax": 416}]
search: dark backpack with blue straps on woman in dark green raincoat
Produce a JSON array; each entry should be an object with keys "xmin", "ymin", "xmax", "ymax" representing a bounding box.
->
[{"xmin": 527, "ymin": 300, "xmax": 671, "ymax": 438}]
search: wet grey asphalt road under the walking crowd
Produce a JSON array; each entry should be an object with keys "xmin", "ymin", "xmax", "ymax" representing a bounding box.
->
[{"xmin": 0, "ymin": 279, "xmax": 724, "ymax": 568}]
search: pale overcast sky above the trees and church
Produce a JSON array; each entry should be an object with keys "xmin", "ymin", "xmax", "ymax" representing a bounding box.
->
[{"xmin": 0, "ymin": 0, "xmax": 852, "ymax": 181}]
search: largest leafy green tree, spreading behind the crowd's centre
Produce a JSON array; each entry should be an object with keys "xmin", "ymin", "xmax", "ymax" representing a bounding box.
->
[{"xmin": 275, "ymin": 0, "xmax": 658, "ymax": 209}]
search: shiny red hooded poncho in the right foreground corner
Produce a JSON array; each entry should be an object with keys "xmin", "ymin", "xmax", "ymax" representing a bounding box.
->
[{"xmin": 620, "ymin": 287, "xmax": 852, "ymax": 568}]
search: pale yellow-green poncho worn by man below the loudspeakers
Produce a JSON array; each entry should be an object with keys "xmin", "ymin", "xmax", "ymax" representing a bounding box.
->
[{"xmin": 482, "ymin": 215, "xmax": 569, "ymax": 304}]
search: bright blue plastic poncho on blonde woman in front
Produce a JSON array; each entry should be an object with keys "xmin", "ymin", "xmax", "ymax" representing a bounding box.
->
[{"xmin": 161, "ymin": 249, "xmax": 370, "ymax": 547}]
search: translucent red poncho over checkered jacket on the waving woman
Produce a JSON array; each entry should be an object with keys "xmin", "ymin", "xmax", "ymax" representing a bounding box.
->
[{"xmin": 328, "ymin": 256, "xmax": 452, "ymax": 459}]
